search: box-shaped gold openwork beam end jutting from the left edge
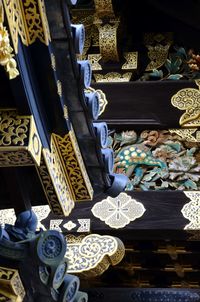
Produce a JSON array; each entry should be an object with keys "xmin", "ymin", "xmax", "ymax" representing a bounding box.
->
[{"xmin": 0, "ymin": 110, "xmax": 42, "ymax": 167}]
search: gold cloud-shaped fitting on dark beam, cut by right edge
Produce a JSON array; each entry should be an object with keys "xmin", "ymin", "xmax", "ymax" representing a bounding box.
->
[{"xmin": 171, "ymin": 80, "xmax": 200, "ymax": 127}]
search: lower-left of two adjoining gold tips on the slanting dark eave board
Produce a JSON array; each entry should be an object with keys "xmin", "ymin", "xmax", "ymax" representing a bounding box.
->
[{"xmin": 37, "ymin": 139, "xmax": 74, "ymax": 216}]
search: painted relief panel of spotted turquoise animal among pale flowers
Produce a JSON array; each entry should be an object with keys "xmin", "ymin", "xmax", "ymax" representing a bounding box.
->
[{"xmin": 109, "ymin": 129, "xmax": 200, "ymax": 190}]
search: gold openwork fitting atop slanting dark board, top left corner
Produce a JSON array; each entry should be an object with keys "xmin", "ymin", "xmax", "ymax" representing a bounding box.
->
[{"xmin": 3, "ymin": 0, "xmax": 51, "ymax": 53}]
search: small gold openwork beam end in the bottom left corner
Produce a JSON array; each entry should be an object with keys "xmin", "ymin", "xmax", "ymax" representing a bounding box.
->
[{"xmin": 0, "ymin": 267, "xmax": 25, "ymax": 302}]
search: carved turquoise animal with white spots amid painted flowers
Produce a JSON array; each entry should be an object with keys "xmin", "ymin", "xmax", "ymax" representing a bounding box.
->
[{"xmin": 115, "ymin": 145, "xmax": 168, "ymax": 184}]
